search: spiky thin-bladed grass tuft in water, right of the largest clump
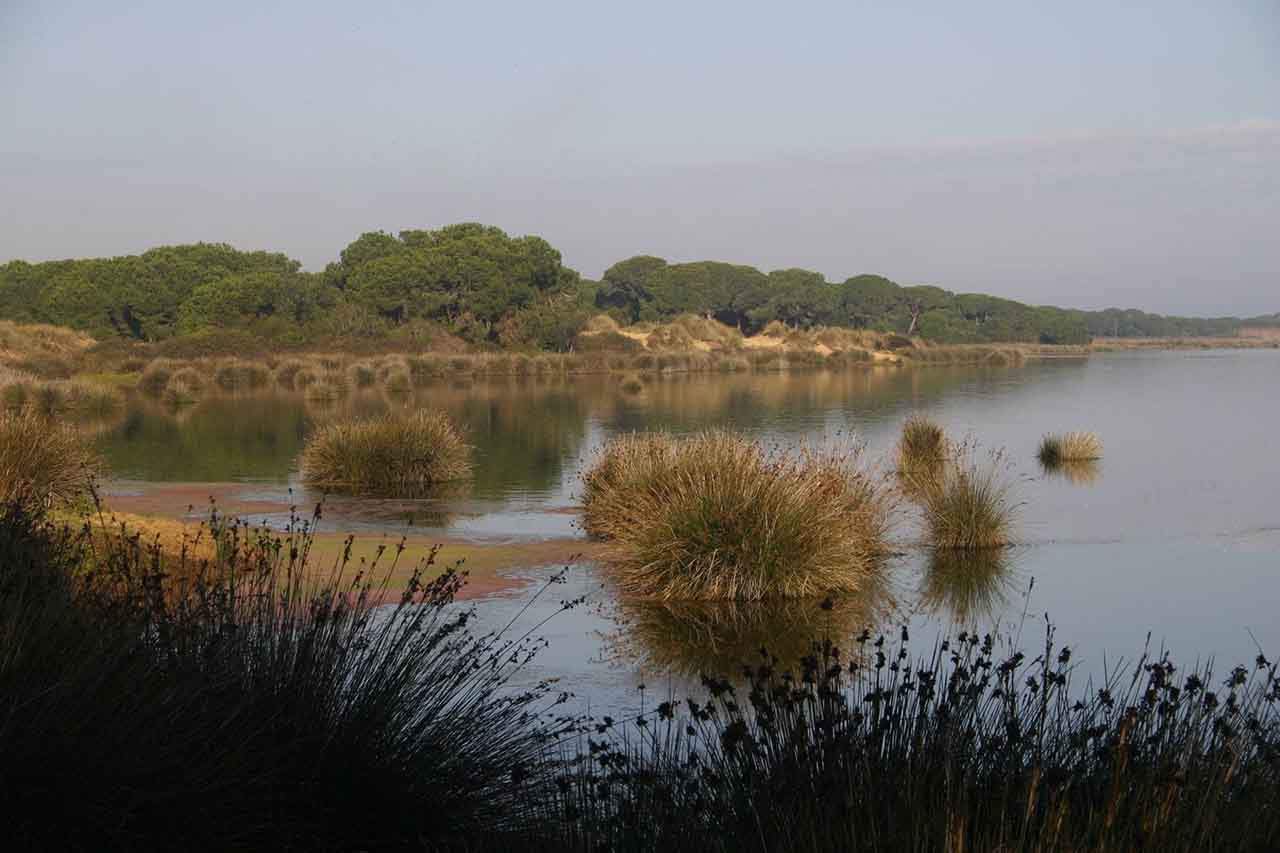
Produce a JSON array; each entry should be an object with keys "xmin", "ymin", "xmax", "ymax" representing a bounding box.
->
[{"xmin": 918, "ymin": 451, "xmax": 1016, "ymax": 549}]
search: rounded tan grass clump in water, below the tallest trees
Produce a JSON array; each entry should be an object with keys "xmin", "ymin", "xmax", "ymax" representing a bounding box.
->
[{"xmin": 302, "ymin": 410, "xmax": 471, "ymax": 497}]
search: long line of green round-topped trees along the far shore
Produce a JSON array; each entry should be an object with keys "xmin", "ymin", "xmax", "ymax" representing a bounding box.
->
[{"xmin": 0, "ymin": 223, "xmax": 1259, "ymax": 350}]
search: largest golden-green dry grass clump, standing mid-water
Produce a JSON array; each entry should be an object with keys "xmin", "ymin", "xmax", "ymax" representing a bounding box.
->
[{"xmin": 584, "ymin": 430, "xmax": 890, "ymax": 599}]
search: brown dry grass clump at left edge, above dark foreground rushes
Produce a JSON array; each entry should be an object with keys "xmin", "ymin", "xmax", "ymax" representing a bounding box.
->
[{"xmin": 0, "ymin": 410, "xmax": 102, "ymax": 511}]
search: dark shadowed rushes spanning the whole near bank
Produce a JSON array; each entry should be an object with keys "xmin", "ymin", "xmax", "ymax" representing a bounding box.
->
[{"xmin": 0, "ymin": 507, "xmax": 1280, "ymax": 852}]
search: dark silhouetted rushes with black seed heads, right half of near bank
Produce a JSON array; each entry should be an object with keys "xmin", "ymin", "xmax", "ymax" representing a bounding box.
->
[{"xmin": 543, "ymin": 629, "xmax": 1280, "ymax": 853}]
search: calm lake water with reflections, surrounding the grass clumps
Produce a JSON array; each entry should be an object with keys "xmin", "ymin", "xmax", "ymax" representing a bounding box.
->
[{"xmin": 100, "ymin": 351, "xmax": 1280, "ymax": 707}]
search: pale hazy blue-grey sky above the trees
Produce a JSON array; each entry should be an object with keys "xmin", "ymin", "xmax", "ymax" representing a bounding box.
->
[{"xmin": 0, "ymin": 0, "xmax": 1280, "ymax": 315}]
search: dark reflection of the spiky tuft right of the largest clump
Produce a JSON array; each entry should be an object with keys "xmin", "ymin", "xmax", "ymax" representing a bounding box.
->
[{"xmin": 919, "ymin": 548, "xmax": 1020, "ymax": 626}]
